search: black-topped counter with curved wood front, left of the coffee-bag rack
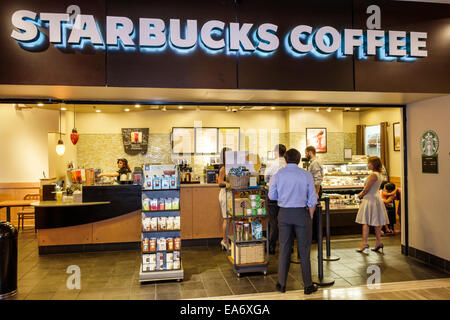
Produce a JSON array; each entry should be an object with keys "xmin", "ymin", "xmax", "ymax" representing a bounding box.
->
[{"xmin": 33, "ymin": 185, "xmax": 141, "ymax": 254}]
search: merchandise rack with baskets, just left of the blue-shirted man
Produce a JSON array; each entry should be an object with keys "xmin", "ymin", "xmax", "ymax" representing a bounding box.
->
[{"xmin": 226, "ymin": 188, "xmax": 269, "ymax": 277}]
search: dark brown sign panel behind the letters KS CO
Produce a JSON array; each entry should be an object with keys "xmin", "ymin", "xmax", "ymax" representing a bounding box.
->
[{"xmin": 238, "ymin": 0, "xmax": 353, "ymax": 91}]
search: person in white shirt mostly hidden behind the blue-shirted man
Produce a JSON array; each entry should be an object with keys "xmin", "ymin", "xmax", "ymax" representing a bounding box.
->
[{"xmin": 264, "ymin": 144, "xmax": 286, "ymax": 254}]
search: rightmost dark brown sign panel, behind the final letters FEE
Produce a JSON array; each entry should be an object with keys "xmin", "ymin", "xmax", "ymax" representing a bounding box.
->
[{"xmin": 354, "ymin": 0, "xmax": 450, "ymax": 93}]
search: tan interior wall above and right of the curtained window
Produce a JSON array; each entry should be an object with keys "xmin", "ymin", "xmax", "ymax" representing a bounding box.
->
[{"xmin": 359, "ymin": 108, "xmax": 402, "ymax": 177}]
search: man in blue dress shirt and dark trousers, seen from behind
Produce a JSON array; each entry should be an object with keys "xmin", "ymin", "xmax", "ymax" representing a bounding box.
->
[{"xmin": 269, "ymin": 149, "xmax": 317, "ymax": 294}]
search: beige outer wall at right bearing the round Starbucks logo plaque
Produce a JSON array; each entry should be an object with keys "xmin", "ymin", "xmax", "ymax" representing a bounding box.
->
[{"xmin": 407, "ymin": 95, "xmax": 450, "ymax": 260}]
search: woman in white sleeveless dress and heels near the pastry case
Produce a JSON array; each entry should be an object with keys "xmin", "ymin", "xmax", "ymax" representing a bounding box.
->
[{"xmin": 356, "ymin": 157, "xmax": 389, "ymax": 252}]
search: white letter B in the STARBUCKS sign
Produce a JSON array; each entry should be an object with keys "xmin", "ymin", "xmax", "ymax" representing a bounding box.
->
[{"xmin": 139, "ymin": 18, "xmax": 166, "ymax": 47}]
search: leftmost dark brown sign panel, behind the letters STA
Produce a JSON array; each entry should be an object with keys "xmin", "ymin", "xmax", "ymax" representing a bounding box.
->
[{"xmin": 0, "ymin": 0, "xmax": 106, "ymax": 86}]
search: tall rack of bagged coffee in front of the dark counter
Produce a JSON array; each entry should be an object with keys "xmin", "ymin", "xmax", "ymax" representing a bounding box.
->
[{"xmin": 139, "ymin": 165, "xmax": 184, "ymax": 282}]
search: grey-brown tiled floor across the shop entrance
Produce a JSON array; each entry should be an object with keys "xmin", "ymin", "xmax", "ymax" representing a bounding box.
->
[{"xmin": 6, "ymin": 230, "xmax": 450, "ymax": 300}]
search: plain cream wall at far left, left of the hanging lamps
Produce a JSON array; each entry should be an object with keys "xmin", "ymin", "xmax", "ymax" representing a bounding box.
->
[{"xmin": 0, "ymin": 104, "xmax": 58, "ymax": 182}]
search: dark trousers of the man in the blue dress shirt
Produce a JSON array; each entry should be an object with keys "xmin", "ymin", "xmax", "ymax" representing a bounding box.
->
[{"xmin": 278, "ymin": 208, "xmax": 312, "ymax": 288}]
